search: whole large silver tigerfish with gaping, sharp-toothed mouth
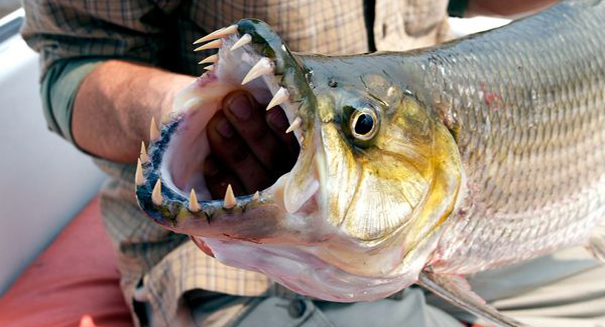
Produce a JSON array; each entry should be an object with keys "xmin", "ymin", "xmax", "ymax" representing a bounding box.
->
[{"xmin": 135, "ymin": 1, "xmax": 605, "ymax": 326}]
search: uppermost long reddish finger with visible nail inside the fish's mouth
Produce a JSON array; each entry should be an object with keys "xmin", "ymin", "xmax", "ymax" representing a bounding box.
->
[{"xmin": 223, "ymin": 91, "xmax": 287, "ymax": 173}]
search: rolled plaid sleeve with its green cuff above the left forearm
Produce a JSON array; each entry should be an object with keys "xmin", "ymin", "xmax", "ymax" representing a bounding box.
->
[{"xmin": 21, "ymin": 0, "xmax": 178, "ymax": 146}]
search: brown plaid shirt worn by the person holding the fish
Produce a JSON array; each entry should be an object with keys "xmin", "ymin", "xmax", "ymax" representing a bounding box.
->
[{"xmin": 22, "ymin": 0, "xmax": 449, "ymax": 325}]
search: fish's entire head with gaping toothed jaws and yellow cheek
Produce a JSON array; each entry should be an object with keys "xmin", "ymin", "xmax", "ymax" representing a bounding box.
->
[{"xmin": 136, "ymin": 20, "xmax": 464, "ymax": 301}]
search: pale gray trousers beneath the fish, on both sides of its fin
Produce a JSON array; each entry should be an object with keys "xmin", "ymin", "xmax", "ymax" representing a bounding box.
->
[{"xmin": 162, "ymin": 248, "xmax": 605, "ymax": 327}]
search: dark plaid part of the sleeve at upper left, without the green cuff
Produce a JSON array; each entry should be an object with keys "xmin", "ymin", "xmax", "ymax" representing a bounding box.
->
[{"xmin": 21, "ymin": 0, "xmax": 178, "ymax": 79}]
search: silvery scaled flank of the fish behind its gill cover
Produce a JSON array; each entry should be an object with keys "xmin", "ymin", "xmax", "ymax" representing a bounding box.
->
[{"xmin": 418, "ymin": 1, "xmax": 605, "ymax": 273}]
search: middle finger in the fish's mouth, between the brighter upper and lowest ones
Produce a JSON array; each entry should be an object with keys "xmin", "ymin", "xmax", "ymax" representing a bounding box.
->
[{"xmin": 207, "ymin": 111, "xmax": 270, "ymax": 193}]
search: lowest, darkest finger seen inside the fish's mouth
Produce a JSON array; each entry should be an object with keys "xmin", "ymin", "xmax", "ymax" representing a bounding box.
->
[{"xmin": 204, "ymin": 154, "xmax": 246, "ymax": 199}]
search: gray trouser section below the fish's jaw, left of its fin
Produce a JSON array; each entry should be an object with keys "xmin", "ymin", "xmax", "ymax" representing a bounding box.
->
[{"xmin": 192, "ymin": 288, "xmax": 464, "ymax": 327}]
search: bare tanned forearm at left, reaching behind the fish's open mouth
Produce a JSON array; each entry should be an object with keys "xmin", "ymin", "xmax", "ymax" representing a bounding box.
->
[{"xmin": 71, "ymin": 60, "xmax": 194, "ymax": 162}]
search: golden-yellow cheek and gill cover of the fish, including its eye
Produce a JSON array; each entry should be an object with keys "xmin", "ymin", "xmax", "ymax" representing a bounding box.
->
[{"xmin": 306, "ymin": 74, "xmax": 463, "ymax": 275}]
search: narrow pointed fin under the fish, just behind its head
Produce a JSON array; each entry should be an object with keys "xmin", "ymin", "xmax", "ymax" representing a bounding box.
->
[{"xmin": 416, "ymin": 271, "xmax": 530, "ymax": 327}]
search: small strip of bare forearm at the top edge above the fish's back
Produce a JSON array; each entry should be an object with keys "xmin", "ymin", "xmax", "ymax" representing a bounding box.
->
[{"xmin": 466, "ymin": 0, "xmax": 560, "ymax": 18}]
